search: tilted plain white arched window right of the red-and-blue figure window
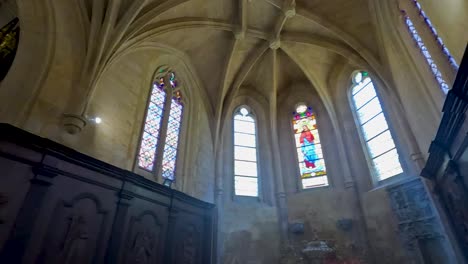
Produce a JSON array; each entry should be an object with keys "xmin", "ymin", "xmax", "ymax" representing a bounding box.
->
[{"xmin": 352, "ymin": 71, "xmax": 403, "ymax": 181}]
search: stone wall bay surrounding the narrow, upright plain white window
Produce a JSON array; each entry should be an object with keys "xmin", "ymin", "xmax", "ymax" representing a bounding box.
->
[{"xmin": 217, "ymin": 87, "xmax": 281, "ymax": 264}]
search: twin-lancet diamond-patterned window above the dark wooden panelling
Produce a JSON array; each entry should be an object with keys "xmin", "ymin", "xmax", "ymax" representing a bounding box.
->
[{"xmin": 138, "ymin": 72, "xmax": 183, "ymax": 185}]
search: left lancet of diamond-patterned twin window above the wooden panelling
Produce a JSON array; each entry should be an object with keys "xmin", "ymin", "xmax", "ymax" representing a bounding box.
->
[{"xmin": 138, "ymin": 82, "xmax": 166, "ymax": 171}]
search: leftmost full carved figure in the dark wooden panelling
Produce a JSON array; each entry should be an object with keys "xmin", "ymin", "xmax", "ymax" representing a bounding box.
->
[{"xmin": 60, "ymin": 216, "xmax": 89, "ymax": 264}]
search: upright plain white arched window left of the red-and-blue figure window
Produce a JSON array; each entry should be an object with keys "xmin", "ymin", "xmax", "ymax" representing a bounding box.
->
[{"xmin": 234, "ymin": 106, "xmax": 258, "ymax": 197}]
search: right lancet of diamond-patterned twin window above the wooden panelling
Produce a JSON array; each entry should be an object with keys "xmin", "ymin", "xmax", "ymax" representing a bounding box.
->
[{"xmin": 162, "ymin": 99, "xmax": 183, "ymax": 181}]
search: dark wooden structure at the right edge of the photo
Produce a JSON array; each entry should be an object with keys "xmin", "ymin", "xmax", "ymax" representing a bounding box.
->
[{"xmin": 421, "ymin": 44, "xmax": 468, "ymax": 261}]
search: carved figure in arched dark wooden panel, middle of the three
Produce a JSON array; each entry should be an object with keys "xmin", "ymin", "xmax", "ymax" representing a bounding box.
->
[{"xmin": 131, "ymin": 230, "xmax": 156, "ymax": 264}]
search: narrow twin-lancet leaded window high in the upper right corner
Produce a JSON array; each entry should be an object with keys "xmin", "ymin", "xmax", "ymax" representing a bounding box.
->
[{"xmin": 401, "ymin": 0, "xmax": 459, "ymax": 94}]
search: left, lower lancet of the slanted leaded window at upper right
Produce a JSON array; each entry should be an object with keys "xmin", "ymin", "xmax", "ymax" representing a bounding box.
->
[{"xmin": 405, "ymin": 15, "xmax": 450, "ymax": 94}]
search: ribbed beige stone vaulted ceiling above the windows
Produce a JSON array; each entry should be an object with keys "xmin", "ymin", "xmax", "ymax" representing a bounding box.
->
[{"xmin": 48, "ymin": 0, "xmax": 379, "ymax": 120}]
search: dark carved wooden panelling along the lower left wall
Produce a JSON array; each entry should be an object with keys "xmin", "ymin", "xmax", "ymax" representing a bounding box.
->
[{"xmin": 0, "ymin": 124, "xmax": 215, "ymax": 264}]
